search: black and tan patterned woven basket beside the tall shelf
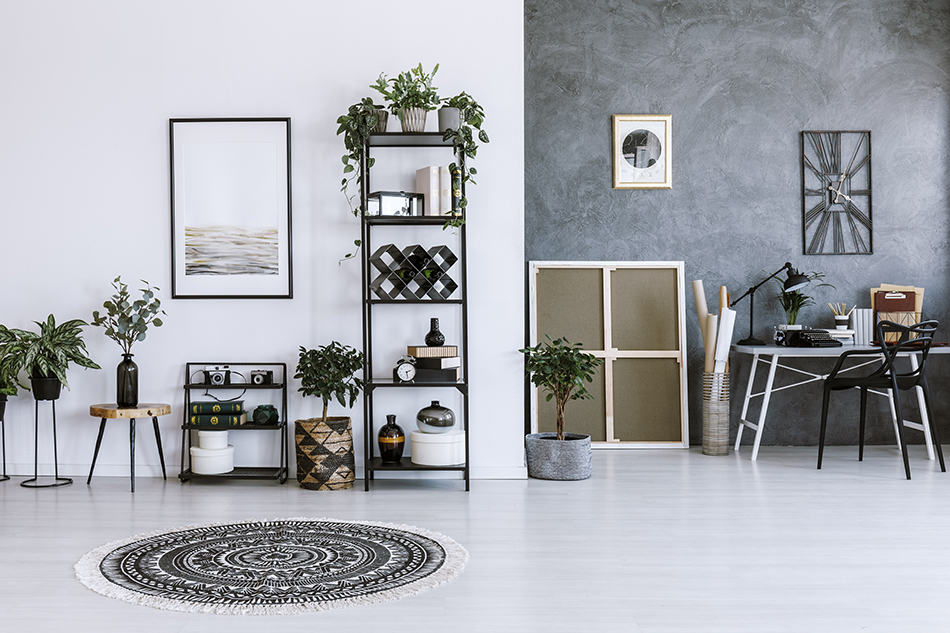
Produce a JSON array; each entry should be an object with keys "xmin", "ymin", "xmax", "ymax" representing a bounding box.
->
[{"xmin": 294, "ymin": 418, "xmax": 356, "ymax": 490}]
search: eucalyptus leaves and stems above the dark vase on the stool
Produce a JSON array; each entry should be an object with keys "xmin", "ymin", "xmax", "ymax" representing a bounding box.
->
[{"xmin": 92, "ymin": 276, "xmax": 165, "ymax": 354}]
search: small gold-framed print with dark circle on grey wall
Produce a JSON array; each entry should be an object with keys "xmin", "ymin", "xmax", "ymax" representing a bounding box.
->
[{"xmin": 613, "ymin": 114, "xmax": 673, "ymax": 189}]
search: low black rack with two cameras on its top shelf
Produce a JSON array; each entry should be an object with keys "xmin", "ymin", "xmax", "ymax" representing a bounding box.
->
[{"xmin": 178, "ymin": 361, "xmax": 289, "ymax": 484}]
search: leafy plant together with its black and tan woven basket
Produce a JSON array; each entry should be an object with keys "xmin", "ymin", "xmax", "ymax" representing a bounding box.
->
[{"xmin": 294, "ymin": 341, "xmax": 363, "ymax": 490}]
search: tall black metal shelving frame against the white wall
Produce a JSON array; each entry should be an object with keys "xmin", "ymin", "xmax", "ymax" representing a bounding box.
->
[{"xmin": 359, "ymin": 132, "xmax": 471, "ymax": 492}]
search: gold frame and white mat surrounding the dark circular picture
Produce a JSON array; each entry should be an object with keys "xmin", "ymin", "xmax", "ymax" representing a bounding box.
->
[{"xmin": 612, "ymin": 114, "xmax": 673, "ymax": 189}]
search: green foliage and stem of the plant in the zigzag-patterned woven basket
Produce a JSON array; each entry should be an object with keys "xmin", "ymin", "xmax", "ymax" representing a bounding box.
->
[{"xmin": 294, "ymin": 341, "xmax": 363, "ymax": 422}]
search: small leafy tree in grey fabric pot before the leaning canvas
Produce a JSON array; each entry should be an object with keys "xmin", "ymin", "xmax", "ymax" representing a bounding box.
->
[{"xmin": 518, "ymin": 336, "xmax": 603, "ymax": 480}]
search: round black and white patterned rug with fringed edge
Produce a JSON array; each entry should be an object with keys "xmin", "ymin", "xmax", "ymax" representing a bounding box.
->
[{"xmin": 76, "ymin": 518, "xmax": 468, "ymax": 615}]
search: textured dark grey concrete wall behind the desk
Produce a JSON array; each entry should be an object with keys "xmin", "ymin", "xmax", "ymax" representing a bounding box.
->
[{"xmin": 525, "ymin": 0, "xmax": 950, "ymax": 445}]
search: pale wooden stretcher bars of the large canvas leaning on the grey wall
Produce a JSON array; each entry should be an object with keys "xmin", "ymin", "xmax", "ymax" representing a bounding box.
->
[{"xmin": 528, "ymin": 261, "xmax": 689, "ymax": 448}]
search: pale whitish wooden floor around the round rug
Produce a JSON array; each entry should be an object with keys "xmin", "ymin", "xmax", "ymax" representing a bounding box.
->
[{"xmin": 0, "ymin": 447, "xmax": 950, "ymax": 633}]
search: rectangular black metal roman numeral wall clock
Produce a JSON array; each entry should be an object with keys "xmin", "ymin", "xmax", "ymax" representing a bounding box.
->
[{"xmin": 802, "ymin": 131, "xmax": 872, "ymax": 255}]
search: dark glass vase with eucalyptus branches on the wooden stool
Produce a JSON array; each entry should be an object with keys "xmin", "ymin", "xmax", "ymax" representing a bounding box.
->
[{"xmin": 92, "ymin": 276, "xmax": 165, "ymax": 407}]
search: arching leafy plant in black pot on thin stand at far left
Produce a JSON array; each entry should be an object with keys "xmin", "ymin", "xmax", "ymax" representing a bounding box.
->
[{"xmin": 0, "ymin": 314, "xmax": 101, "ymax": 400}]
